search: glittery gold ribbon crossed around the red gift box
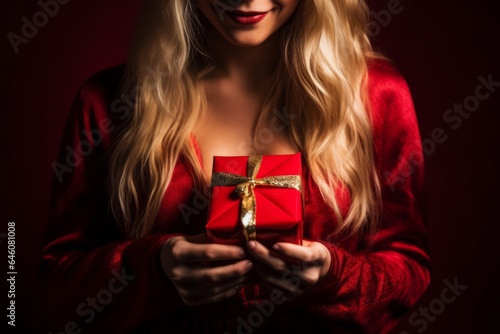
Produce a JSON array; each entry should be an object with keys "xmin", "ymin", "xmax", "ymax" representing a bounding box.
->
[{"xmin": 212, "ymin": 155, "xmax": 302, "ymax": 241}]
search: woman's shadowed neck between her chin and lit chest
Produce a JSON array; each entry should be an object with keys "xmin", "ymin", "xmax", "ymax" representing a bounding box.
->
[{"xmin": 204, "ymin": 31, "xmax": 280, "ymax": 88}]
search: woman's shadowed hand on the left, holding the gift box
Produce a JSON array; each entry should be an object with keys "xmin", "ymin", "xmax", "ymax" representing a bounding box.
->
[{"xmin": 160, "ymin": 234, "xmax": 253, "ymax": 306}]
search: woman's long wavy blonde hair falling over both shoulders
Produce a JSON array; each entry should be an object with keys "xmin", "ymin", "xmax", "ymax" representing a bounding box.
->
[{"xmin": 109, "ymin": 0, "xmax": 380, "ymax": 238}]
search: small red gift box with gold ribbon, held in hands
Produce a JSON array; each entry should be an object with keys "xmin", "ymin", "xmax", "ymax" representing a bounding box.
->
[{"xmin": 206, "ymin": 153, "xmax": 303, "ymax": 248}]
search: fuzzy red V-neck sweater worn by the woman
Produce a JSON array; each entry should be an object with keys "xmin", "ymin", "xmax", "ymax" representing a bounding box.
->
[{"xmin": 42, "ymin": 61, "xmax": 430, "ymax": 333}]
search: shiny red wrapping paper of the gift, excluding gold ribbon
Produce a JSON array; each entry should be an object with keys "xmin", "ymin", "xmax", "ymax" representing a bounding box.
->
[{"xmin": 206, "ymin": 153, "xmax": 303, "ymax": 248}]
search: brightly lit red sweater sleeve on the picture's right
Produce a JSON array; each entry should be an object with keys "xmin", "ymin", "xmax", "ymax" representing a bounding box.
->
[{"xmin": 296, "ymin": 62, "xmax": 430, "ymax": 333}]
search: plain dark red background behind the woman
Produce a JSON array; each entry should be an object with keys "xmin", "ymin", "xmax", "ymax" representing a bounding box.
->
[{"xmin": 0, "ymin": 0, "xmax": 500, "ymax": 334}]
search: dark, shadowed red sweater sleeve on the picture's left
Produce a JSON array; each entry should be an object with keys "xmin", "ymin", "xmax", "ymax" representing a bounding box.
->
[{"xmin": 41, "ymin": 69, "xmax": 184, "ymax": 333}]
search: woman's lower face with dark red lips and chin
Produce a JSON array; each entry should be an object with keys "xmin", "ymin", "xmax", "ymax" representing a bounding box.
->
[{"xmin": 196, "ymin": 0, "xmax": 299, "ymax": 47}]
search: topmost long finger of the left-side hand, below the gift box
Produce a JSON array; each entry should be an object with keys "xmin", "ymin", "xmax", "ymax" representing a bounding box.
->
[{"xmin": 172, "ymin": 240, "xmax": 246, "ymax": 263}]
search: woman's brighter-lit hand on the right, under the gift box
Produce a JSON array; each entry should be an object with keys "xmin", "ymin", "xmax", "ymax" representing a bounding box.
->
[{"xmin": 247, "ymin": 240, "xmax": 331, "ymax": 298}]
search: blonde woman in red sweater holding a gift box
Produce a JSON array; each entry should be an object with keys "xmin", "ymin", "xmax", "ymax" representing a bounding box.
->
[{"xmin": 43, "ymin": 0, "xmax": 429, "ymax": 333}]
